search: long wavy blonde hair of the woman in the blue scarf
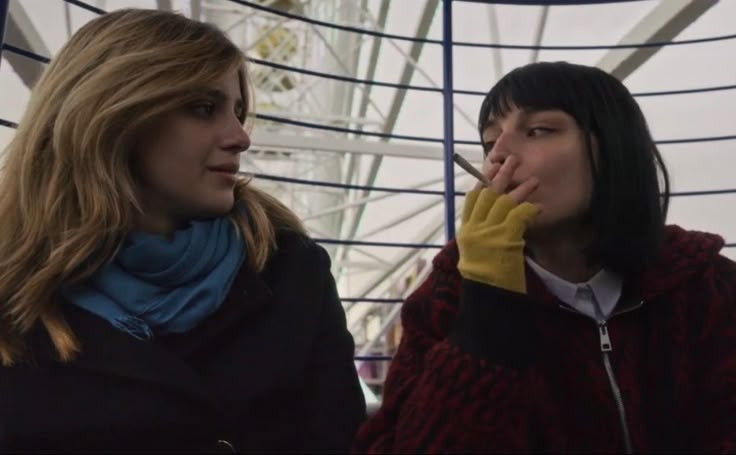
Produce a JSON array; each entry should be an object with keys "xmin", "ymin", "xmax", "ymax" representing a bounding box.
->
[{"xmin": 0, "ymin": 9, "xmax": 304, "ymax": 366}]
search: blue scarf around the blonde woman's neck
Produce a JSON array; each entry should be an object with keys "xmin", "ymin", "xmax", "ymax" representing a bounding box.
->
[{"xmin": 62, "ymin": 217, "xmax": 245, "ymax": 340}]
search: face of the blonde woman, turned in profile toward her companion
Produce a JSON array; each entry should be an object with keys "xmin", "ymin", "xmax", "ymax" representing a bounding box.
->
[{"xmin": 134, "ymin": 71, "xmax": 250, "ymax": 231}]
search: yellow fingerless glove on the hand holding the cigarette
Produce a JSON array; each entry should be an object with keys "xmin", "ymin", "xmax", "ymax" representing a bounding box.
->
[{"xmin": 457, "ymin": 188, "xmax": 539, "ymax": 294}]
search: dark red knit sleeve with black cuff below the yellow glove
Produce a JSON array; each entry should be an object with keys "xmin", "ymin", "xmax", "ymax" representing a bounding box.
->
[{"xmin": 353, "ymin": 267, "xmax": 534, "ymax": 453}]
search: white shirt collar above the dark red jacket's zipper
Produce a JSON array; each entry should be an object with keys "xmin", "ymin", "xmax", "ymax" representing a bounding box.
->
[{"xmin": 526, "ymin": 257, "xmax": 623, "ymax": 322}]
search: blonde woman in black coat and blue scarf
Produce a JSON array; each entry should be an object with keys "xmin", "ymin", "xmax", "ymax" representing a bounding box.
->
[{"xmin": 0, "ymin": 9, "xmax": 365, "ymax": 452}]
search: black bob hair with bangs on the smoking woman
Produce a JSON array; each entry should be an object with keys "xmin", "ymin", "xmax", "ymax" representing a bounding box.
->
[{"xmin": 478, "ymin": 62, "xmax": 670, "ymax": 275}]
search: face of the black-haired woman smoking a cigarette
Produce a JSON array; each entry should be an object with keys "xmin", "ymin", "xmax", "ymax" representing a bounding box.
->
[{"xmin": 482, "ymin": 106, "xmax": 595, "ymax": 230}]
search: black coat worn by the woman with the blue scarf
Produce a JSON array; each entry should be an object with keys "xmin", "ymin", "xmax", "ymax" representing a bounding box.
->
[{"xmin": 0, "ymin": 235, "xmax": 365, "ymax": 453}]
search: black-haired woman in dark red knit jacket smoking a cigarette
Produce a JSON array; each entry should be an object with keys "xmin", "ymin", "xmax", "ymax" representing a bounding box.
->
[{"xmin": 354, "ymin": 63, "xmax": 736, "ymax": 453}]
